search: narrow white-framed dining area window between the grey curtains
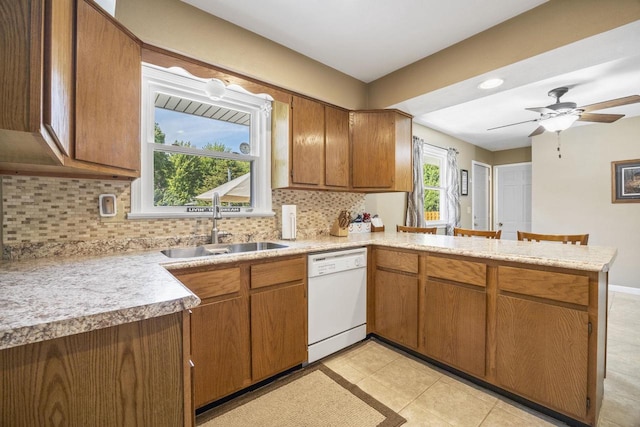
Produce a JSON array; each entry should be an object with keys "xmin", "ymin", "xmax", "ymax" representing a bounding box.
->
[{"xmin": 422, "ymin": 144, "xmax": 447, "ymax": 225}]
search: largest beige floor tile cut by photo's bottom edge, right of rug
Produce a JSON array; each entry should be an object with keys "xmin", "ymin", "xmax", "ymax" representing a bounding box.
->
[{"xmin": 413, "ymin": 377, "xmax": 495, "ymax": 427}]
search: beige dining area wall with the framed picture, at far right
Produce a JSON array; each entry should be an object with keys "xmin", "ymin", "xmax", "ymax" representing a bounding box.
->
[{"xmin": 531, "ymin": 117, "xmax": 640, "ymax": 288}]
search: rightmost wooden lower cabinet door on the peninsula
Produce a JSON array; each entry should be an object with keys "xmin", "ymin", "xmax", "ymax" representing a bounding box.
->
[{"xmin": 496, "ymin": 295, "xmax": 589, "ymax": 418}]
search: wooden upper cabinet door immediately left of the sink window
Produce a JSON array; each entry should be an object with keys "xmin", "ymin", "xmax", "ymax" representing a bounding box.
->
[{"xmin": 75, "ymin": 0, "xmax": 141, "ymax": 170}]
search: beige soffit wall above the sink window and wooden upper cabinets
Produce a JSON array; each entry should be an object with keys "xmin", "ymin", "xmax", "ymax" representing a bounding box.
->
[{"xmin": 116, "ymin": 0, "xmax": 367, "ymax": 109}]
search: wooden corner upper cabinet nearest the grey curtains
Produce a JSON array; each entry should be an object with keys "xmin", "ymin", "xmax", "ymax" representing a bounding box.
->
[{"xmin": 350, "ymin": 110, "xmax": 413, "ymax": 192}]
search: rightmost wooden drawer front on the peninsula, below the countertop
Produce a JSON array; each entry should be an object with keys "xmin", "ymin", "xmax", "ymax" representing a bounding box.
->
[{"xmin": 498, "ymin": 267, "xmax": 589, "ymax": 305}]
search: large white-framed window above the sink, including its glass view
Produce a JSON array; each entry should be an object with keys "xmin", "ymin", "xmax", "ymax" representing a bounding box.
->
[{"xmin": 129, "ymin": 64, "xmax": 273, "ymax": 218}]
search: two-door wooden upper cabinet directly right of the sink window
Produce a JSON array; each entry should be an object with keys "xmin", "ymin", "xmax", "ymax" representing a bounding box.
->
[{"xmin": 271, "ymin": 96, "xmax": 349, "ymax": 191}]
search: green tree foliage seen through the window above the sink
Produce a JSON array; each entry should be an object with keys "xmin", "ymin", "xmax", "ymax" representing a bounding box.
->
[{"xmin": 153, "ymin": 123, "xmax": 251, "ymax": 206}]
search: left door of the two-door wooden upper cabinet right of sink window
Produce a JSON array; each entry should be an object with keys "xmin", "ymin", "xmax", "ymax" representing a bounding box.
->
[{"xmin": 291, "ymin": 97, "xmax": 324, "ymax": 185}]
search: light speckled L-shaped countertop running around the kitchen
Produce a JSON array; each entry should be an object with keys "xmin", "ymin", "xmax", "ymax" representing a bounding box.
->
[{"xmin": 0, "ymin": 232, "xmax": 616, "ymax": 349}]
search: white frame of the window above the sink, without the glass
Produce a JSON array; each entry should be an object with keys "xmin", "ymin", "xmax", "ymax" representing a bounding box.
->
[{"xmin": 127, "ymin": 63, "xmax": 275, "ymax": 219}]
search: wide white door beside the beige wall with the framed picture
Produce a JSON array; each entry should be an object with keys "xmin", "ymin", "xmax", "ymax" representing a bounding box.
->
[{"xmin": 494, "ymin": 163, "xmax": 531, "ymax": 240}]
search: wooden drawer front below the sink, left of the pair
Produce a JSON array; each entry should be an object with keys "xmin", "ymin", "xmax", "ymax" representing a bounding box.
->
[{"xmin": 175, "ymin": 267, "xmax": 240, "ymax": 299}]
